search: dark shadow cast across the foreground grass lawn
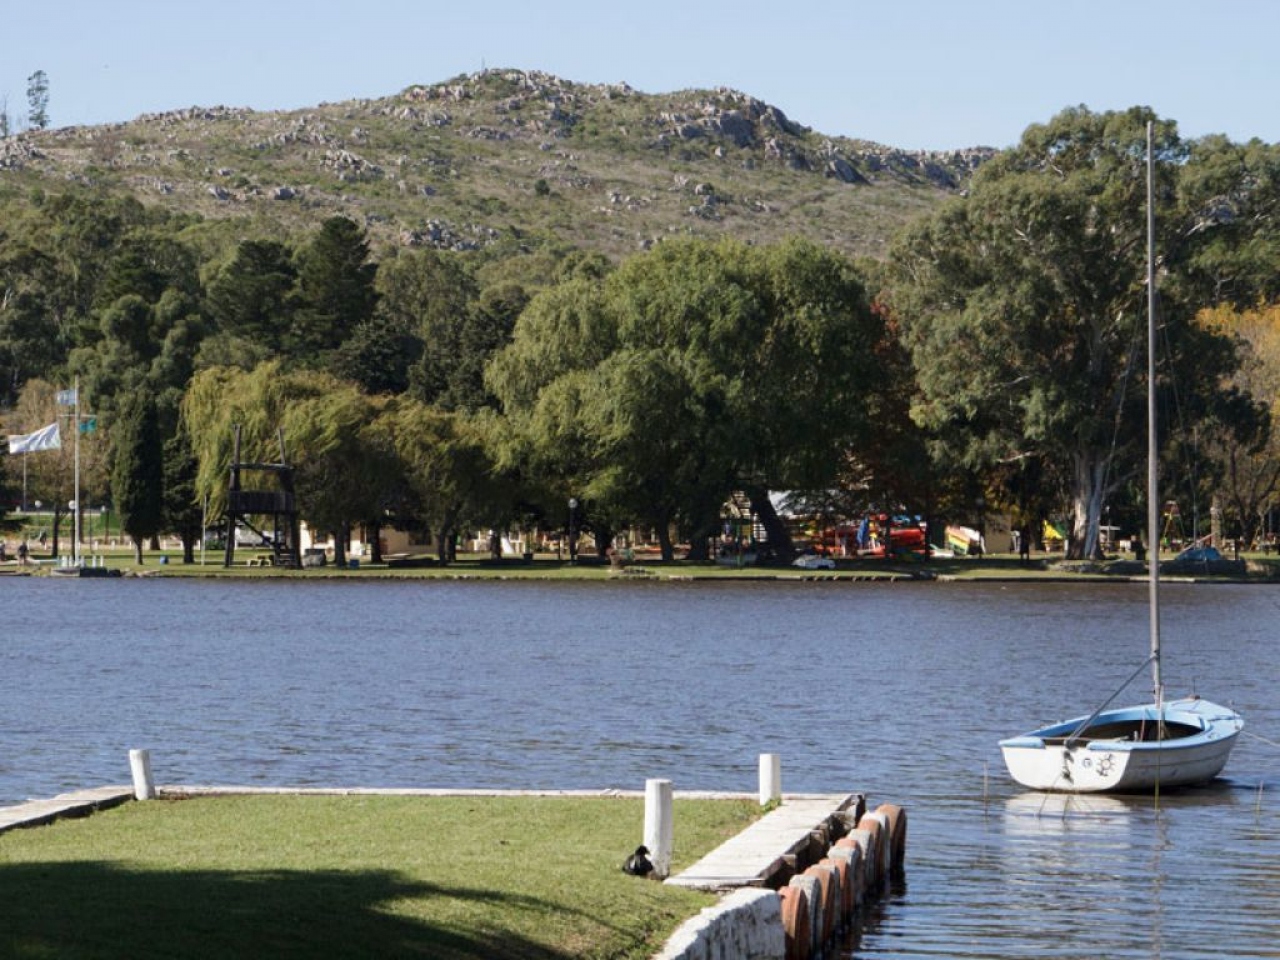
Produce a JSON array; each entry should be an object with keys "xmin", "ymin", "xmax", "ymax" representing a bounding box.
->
[{"xmin": 0, "ymin": 863, "xmax": 570, "ymax": 960}]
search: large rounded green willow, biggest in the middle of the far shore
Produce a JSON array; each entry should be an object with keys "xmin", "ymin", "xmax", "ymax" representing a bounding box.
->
[{"xmin": 488, "ymin": 241, "xmax": 882, "ymax": 556}]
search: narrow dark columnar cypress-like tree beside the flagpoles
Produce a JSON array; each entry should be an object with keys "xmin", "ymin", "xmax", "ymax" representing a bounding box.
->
[{"xmin": 111, "ymin": 393, "xmax": 164, "ymax": 563}]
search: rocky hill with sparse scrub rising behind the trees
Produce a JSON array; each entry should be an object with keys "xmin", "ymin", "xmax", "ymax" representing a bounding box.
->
[{"xmin": 0, "ymin": 69, "xmax": 992, "ymax": 256}]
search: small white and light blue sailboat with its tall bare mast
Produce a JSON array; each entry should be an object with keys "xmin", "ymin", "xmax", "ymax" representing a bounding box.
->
[{"xmin": 1000, "ymin": 122, "xmax": 1244, "ymax": 794}]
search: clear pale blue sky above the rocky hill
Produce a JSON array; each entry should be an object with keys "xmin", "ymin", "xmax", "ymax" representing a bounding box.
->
[{"xmin": 0, "ymin": 0, "xmax": 1280, "ymax": 150}]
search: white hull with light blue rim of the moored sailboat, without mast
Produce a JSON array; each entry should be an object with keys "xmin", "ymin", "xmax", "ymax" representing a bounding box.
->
[{"xmin": 1000, "ymin": 698, "xmax": 1244, "ymax": 794}]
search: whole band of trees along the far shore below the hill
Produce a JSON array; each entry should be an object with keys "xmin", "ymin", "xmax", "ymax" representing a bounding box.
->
[{"xmin": 0, "ymin": 108, "xmax": 1280, "ymax": 559}]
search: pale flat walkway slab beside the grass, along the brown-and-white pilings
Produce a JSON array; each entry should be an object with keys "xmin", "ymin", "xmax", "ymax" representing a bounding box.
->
[{"xmin": 667, "ymin": 794, "xmax": 863, "ymax": 890}]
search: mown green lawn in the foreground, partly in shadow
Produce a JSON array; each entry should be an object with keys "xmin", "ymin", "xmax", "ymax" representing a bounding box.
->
[{"xmin": 0, "ymin": 796, "xmax": 760, "ymax": 960}]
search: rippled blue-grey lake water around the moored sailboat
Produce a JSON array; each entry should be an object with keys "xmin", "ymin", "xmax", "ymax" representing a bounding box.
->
[{"xmin": 0, "ymin": 577, "xmax": 1280, "ymax": 957}]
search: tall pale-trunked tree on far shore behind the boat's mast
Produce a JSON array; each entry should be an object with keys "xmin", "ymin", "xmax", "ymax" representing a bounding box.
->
[{"xmin": 891, "ymin": 108, "xmax": 1254, "ymax": 558}]
